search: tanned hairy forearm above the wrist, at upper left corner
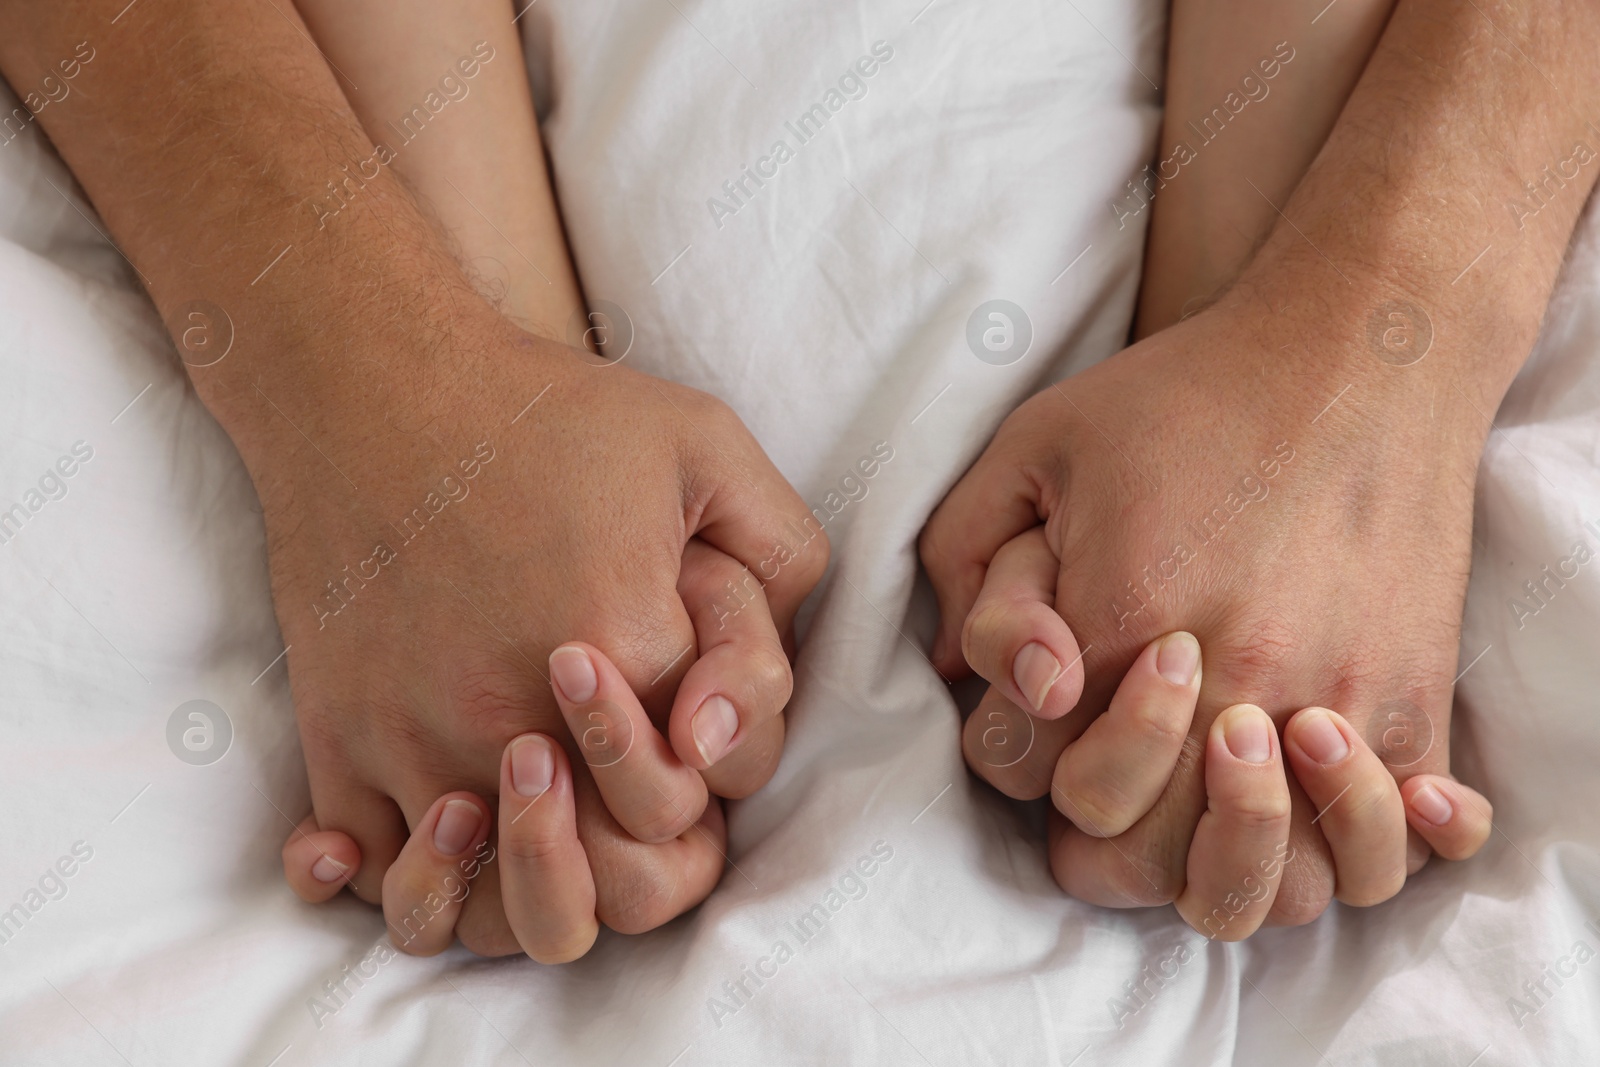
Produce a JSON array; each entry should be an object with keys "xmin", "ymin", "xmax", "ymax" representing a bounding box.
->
[{"xmin": 0, "ymin": 0, "xmax": 505, "ymax": 475}]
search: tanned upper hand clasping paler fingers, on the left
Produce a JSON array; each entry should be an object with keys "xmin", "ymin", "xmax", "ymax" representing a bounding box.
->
[{"xmin": 253, "ymin": 317, "xmax": 827, "ymax": 949}]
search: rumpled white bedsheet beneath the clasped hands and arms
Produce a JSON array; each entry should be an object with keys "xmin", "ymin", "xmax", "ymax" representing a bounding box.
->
[{"xmin": 0, "ymin": 0, "xmax": 1600, "ymax": 1067}]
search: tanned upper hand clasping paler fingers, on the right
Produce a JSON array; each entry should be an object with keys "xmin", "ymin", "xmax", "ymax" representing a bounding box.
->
[{"xmin": 923, "ymin": 295, "xmax": 1488, "ymax": 933}]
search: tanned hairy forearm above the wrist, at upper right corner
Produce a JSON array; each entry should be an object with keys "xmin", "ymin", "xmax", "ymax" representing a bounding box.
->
[{"xmin": 1229, "ymin": 0, "xmax": 1600, "ymax": 435}]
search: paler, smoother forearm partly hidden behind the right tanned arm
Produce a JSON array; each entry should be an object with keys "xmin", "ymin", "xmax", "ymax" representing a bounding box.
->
[{"xmin": 1136, "ymin": 0, "xmax": 1394, "ymax": 338}]
